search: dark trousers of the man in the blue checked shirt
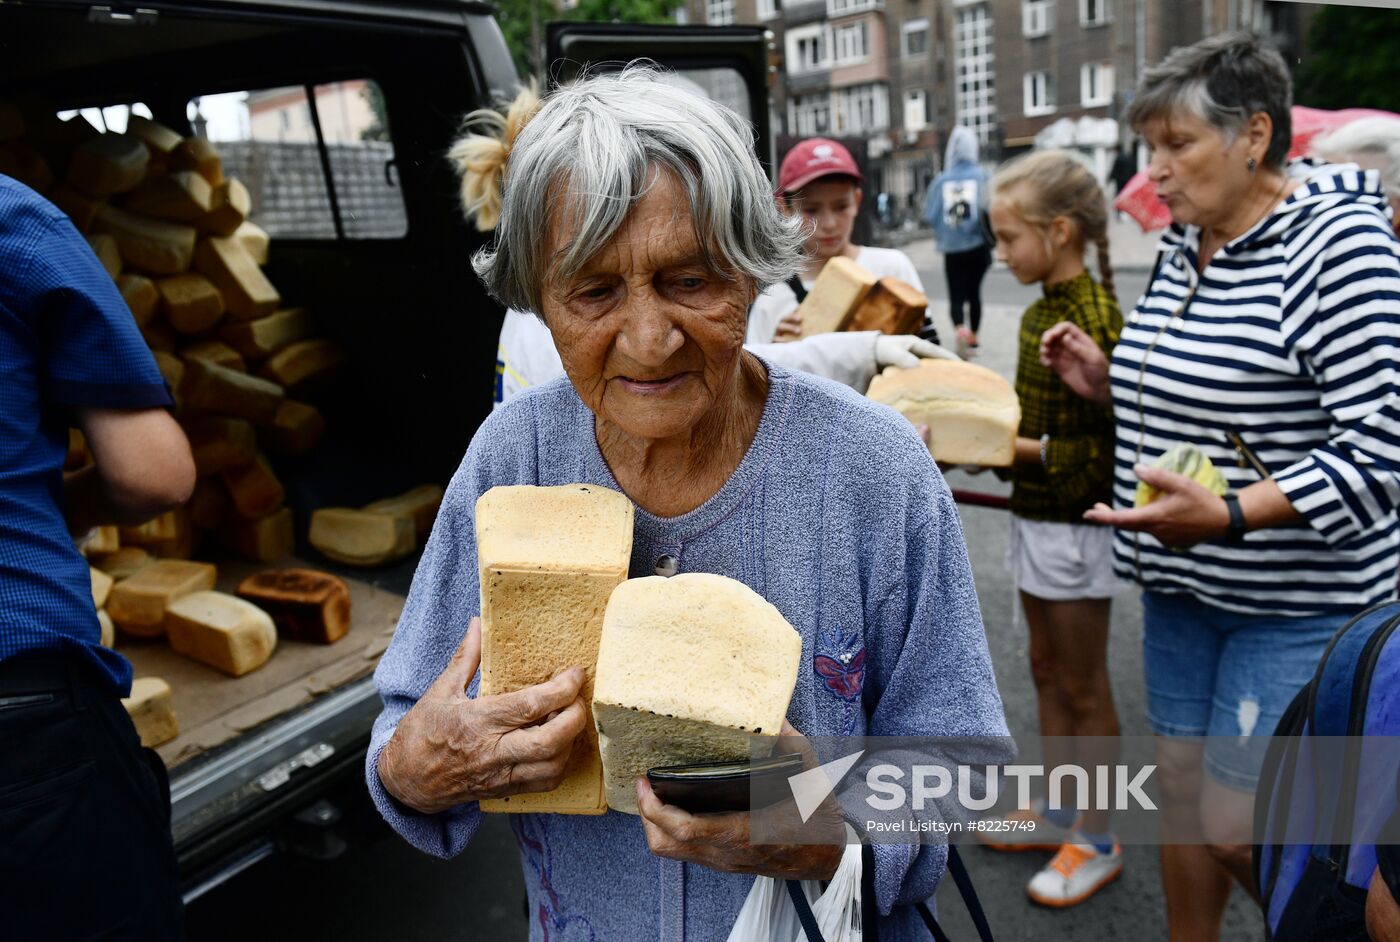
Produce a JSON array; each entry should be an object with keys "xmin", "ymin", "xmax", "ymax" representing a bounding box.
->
[{"xmin": 0, "ymin": 654, "xmax": 183, "ymax": 942}]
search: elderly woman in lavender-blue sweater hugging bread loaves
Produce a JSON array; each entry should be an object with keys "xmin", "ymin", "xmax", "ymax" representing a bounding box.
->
[{"xmin": 365, "ymin": 67, "xmax": 1005, "ymax": 942}]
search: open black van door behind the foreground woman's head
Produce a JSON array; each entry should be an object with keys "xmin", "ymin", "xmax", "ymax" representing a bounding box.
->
[{"xmin": 546, "ymin": 22, "xmax": 776, "ymax": 179}]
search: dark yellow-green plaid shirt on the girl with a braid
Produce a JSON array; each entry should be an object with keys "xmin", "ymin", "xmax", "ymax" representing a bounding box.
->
[{"xmin": 1011, "ymin": 272, "xmax": 1123, "ymax": 523}]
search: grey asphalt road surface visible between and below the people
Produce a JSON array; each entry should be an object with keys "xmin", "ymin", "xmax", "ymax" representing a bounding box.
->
[{"xmin": 188, "ymin": 260, "xmax": 1263, "ymax": 942}]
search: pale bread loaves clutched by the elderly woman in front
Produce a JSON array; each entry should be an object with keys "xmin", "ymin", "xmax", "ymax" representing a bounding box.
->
[{"xmin": 476, "ymin": 484, "xmax": 802, "ymax": 815}]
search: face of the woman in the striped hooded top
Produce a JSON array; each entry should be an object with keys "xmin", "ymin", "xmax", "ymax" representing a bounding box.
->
[{"xmin": 1142, "ymin": 111, "xmax": 1250, "ymax": 227}]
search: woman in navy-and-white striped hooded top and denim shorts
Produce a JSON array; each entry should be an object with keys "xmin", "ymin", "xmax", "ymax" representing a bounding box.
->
[{"xmin": 1042, "ymin": 35, "xmax": 1400, "ymax": 939}]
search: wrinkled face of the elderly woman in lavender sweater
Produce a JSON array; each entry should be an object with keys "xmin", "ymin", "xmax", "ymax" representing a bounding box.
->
[{"xmin": 542, "ymin": 172, "xmax": 753, "ymax": 440}]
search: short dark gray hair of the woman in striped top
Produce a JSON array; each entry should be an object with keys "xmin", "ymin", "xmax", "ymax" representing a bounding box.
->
[{"xmin": 1127, "ymin": 32, "xmax": 1294, "ymax": 169}]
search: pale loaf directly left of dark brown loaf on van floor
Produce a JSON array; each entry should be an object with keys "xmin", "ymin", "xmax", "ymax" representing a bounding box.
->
[{"xmin": 165, "ymin": 591, "xmax": 277, "ymax": 677}]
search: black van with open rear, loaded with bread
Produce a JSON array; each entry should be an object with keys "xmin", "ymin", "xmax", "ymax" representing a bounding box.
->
[{"xmin": 0, "ymin": 0, "xmax": 773, "ymax": 900}]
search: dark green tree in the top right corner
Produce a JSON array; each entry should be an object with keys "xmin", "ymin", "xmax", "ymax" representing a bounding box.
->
[{"xmin": 1294, "ymin": 7, "xmax": 1400, "ymax": 112}]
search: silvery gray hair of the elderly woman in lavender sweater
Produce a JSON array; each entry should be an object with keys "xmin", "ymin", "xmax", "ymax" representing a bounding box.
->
[{"xmin": 472, "ymin": 63, "xmax": 806, "ymax": 314}]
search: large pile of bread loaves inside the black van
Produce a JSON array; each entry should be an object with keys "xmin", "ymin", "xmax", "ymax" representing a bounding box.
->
[{"xmin": 0, "ymin": 102, "xmax": 459, "ymax": 745}]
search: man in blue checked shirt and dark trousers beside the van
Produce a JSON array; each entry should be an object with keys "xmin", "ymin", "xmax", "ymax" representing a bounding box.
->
[{"xmin": 0, "ymin": 175, "xmax": 195, "ymax": 942}]
